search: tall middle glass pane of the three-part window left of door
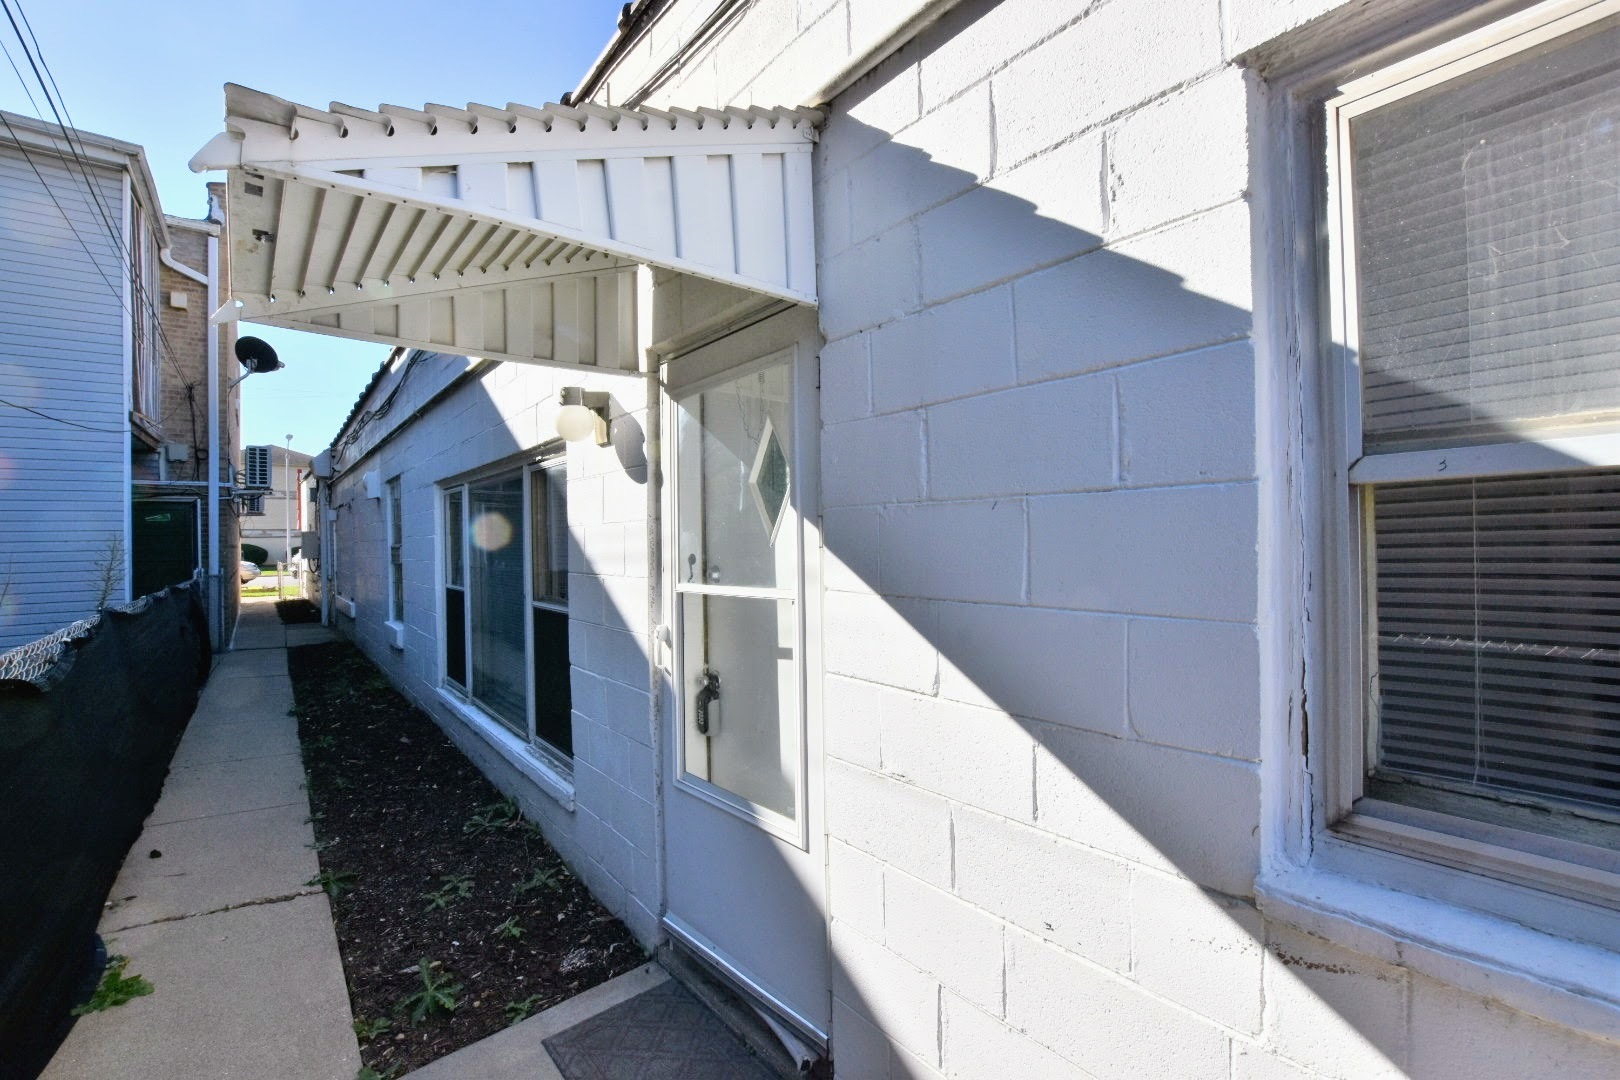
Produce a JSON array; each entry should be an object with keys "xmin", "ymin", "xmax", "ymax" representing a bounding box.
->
[{"xmin": 467, "ymin": 473, "xmax": 528, "ymax": 735}]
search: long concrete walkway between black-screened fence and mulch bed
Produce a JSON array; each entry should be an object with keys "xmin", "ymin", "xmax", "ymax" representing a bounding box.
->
[{"xmin": 44, "ymin": 599, "xmax": 360, "ymax": 1080}]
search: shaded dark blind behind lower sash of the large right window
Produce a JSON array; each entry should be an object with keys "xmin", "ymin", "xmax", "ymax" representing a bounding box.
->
[{"xmin": 1371, "ymin": 471, "xmax": 1620, "ymax": 813}]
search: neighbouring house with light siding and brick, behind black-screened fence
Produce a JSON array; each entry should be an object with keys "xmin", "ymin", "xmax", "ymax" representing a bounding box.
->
[{"xmin": 0, "ymin": 113, "xmax": 238, "ymax": 648}]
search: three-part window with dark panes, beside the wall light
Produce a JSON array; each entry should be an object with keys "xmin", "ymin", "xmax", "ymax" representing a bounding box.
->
[{"xmin": 442, "ymin": 458, "xmax": 573, "ymax": 759}]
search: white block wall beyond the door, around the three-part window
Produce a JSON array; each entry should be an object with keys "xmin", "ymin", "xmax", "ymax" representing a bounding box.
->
[{"xmin": 332, "ymin": 355, "xmax": 659, "ymax": 944}]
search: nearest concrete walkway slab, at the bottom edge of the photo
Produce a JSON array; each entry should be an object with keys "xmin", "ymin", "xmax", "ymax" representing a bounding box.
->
[{"xmin": 44, "ymin": 894, "xmax": 360, "ymax": 1080}]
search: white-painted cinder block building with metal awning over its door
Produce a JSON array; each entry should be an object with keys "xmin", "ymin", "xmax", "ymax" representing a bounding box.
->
[{"xmin": 196, "ymin": 0, "xmax": 1620, "ymax": 1078}]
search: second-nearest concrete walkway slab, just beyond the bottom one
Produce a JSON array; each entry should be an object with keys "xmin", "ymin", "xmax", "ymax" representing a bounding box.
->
[{"xmin": 102, "ymin": 803, "xmax": 321, "ymax": 934}]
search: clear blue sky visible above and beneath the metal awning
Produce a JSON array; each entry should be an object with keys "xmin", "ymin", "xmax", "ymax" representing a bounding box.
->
[{"xmin": 0, "ymin": 0, "xmax": 622, "ymax": 453}]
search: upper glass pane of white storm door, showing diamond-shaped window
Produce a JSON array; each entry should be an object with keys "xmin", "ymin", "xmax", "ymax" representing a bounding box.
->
[{"xmin": 676, "ymin": 363, "xmax": 795, "ymax": 589}]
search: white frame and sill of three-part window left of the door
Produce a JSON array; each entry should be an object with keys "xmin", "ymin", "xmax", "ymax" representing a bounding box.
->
[{"xmin": 434, "ymin": 442, "xmax": 573, "ymax": 810}]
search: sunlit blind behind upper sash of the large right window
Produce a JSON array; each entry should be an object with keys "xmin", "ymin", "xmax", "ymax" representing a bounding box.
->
[{"xmin": 1351, "ymin": 19, "xmax": 1620, "ymax": 450}]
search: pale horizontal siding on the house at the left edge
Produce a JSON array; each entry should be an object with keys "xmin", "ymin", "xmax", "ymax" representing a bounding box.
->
[{"xmin": 0, "ymin": 147, "xmax": 130, "ymax": 648}]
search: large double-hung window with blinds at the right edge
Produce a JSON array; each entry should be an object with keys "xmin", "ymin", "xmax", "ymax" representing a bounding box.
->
[{"xmin": 1325, "ymin": 5, "xmax": 1620, "ymax": 904}]
